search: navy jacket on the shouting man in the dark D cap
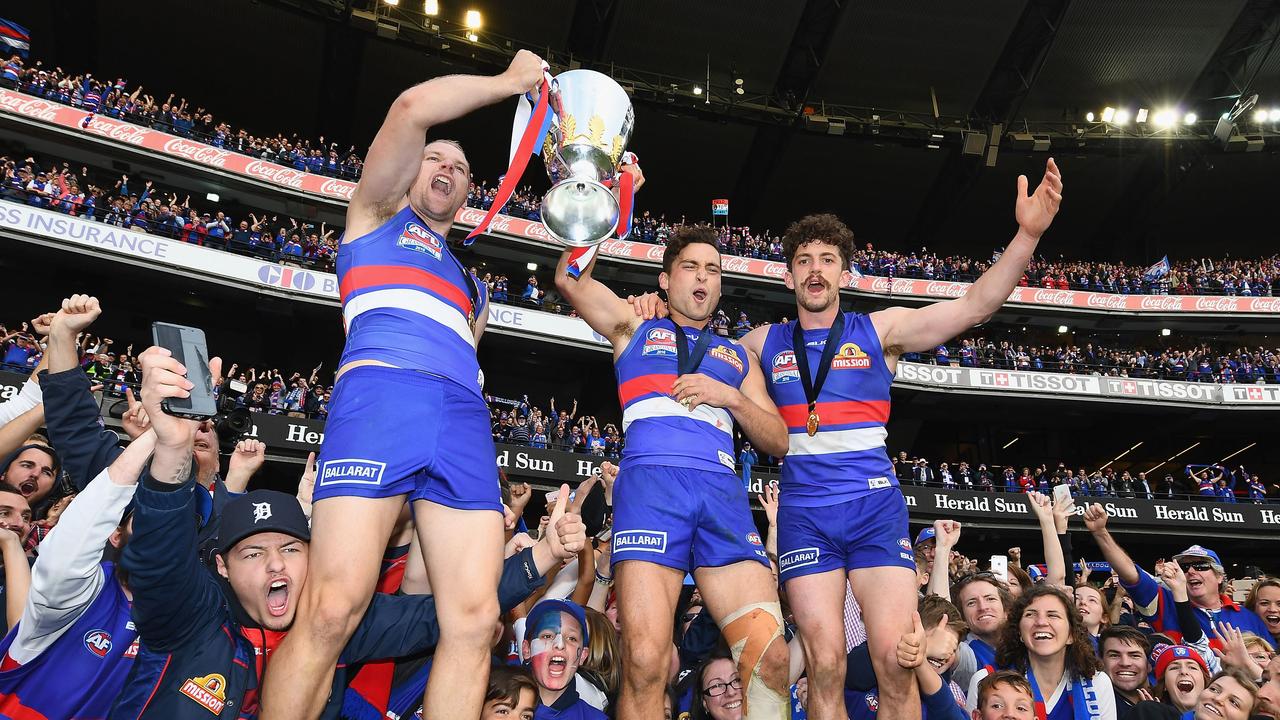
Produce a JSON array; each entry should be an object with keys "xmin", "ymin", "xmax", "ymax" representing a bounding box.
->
[{"xmin": 109, "ymin": 468, "xmax": 543, "ymax": 720}]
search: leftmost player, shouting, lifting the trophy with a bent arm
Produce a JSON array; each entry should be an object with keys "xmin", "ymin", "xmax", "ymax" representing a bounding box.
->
[{"xmin": 262, "ymin": 50, "xmax": 544, "ymax": 720}]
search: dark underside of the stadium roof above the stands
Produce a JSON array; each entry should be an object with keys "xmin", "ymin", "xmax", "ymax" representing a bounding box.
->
[{"xmin": 10, "ymin": 0, "xmax": 1280, "ymax": 263}]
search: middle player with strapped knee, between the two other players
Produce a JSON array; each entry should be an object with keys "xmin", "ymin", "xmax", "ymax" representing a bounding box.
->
[{"xmin": 556, "ymin": 225, "xmax": 793, "ymax": 720}]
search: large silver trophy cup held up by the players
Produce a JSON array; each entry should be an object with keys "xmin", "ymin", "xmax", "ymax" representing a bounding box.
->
[{"xmin": 543, "ymin": 70, "xmax": 635, "ymax": 247}]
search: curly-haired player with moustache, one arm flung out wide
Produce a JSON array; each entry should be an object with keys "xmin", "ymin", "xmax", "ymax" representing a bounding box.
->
[{"xmin": 742, "ymin": 159, "xmax": 1062, "ymax": 720}]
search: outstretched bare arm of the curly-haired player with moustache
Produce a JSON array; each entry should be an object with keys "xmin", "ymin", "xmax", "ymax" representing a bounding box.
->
[{"xmin": 872, "ymin": 158, "xmax": 1062, "ymax": 356}]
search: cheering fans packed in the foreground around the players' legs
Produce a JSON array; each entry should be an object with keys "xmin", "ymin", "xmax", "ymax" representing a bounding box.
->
[{"xmin": 0, "ymin": 293, "xmax": 1280, "ymax": 720}]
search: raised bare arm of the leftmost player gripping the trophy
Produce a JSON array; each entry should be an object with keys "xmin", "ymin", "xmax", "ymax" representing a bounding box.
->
[{"xmin": 347, "ymin": 50, "xmax": 543, "ymax": 238}]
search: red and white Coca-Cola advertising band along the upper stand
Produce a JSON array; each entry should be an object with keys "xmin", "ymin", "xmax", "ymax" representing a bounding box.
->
[{"xmin": 0, "ymin": 88, "xmax": 1280, "ymax": 316}]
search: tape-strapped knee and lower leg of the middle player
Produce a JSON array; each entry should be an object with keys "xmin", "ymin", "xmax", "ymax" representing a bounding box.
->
[{"xmin": 721, "ymin": 602, "xmax": 790, "ymax": 720}]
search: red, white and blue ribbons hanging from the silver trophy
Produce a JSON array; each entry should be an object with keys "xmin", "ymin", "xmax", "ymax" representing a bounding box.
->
[{"xmin": 463, "ymin": 63, "xmax": 636, "ymax": 278}]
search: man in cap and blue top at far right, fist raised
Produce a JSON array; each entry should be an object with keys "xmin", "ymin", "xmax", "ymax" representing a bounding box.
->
[{"xmin": 1084, "ymin": 503, "xmax": 1275, "ymax": 647}]
